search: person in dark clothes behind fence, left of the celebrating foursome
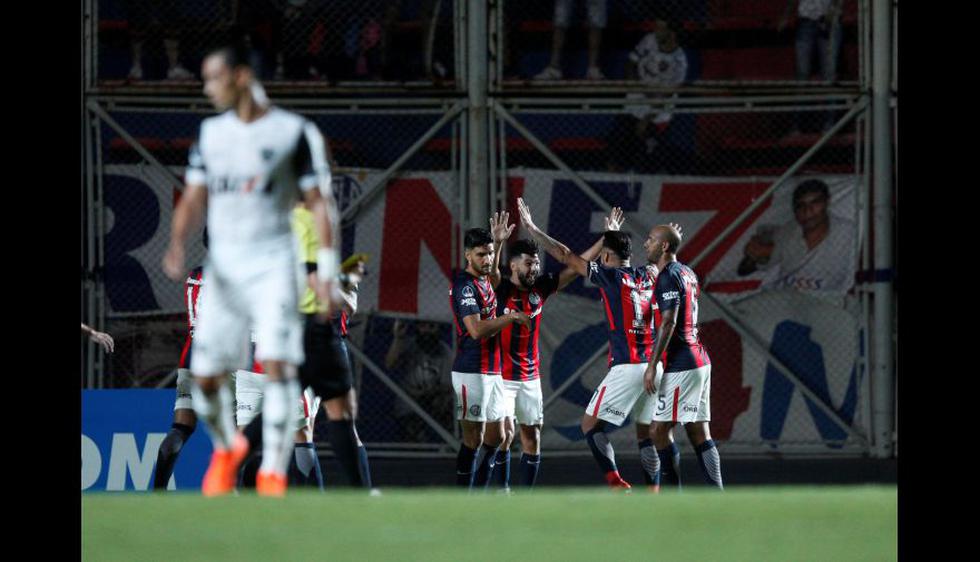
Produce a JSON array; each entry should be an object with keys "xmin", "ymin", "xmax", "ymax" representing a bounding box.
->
[{"xmin": 385, "ymin": 320, "xmax": 454, "ymax": 443}]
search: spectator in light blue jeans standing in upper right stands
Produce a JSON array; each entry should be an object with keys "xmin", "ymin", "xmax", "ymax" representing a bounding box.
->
[{"xmin": 777, "ymin": 0, "xmax": 843, "ymax": 82}]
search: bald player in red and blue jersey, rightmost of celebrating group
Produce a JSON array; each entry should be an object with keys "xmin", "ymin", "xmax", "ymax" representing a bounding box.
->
[{"xmin": 643, "ymin": 225, "xmax": 723, "ymax": 489}]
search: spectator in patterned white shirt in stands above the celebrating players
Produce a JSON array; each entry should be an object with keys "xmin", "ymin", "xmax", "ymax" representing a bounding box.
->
[{"xmin": 606, "ymin": 20, "xmax": 688, "ymax": 173}]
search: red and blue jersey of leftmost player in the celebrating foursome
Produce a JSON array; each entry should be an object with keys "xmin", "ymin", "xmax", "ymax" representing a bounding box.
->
[{"xmin": 449, "ymin": 270, "xmax": 500, "ymax": 375}]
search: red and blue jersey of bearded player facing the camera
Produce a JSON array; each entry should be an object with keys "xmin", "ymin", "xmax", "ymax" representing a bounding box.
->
[{"xmin": 497, "ymin": 273, "xmax": 558, "ymax": 381}]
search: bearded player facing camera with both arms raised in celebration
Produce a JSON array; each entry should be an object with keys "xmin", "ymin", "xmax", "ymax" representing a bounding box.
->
[{"xmin": 494, "ymin": 207, "xmax": 623, "ymax": 489}]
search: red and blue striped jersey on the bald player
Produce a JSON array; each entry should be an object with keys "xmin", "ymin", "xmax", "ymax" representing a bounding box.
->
[{"xmin": 654, "ymin": 261, "xmax": 711, "ymax": 373}]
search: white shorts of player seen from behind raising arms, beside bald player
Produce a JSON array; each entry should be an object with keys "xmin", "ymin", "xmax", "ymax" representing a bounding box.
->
[{"xmin": 585, "ymin": 361, "xmax": 664, "ymax": 425}]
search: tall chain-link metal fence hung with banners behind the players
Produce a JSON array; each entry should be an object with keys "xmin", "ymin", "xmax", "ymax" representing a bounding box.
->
[{"xmin": 82, "ymin": 0, "xmax": 888, "ymax": 455}]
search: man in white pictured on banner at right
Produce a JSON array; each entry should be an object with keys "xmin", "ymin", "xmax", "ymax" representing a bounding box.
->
[{"xmin": 738, "ymin": 179, "xmax": 858, "ymax": 293}]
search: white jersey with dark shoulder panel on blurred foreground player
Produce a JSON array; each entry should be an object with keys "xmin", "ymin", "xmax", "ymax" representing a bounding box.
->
[{"xmin": 186, "ymin": 107, "xmax": 330, "ymax": 271}]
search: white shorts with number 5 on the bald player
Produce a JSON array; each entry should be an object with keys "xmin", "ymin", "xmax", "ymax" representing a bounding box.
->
[{"xmin": 653, "ymin": 364, "xmax": 711, "ymax": 423}]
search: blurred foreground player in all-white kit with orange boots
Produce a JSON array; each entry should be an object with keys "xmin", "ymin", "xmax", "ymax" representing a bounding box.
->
[{"xmin": 163, "ymin": 43, "xmax": 339, "ymax": 496}]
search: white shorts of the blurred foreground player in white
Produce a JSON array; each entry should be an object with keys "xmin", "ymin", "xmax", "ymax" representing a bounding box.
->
[{"xmin": 191, "ymin": 260, "xmax": 303, "ymax": 376}]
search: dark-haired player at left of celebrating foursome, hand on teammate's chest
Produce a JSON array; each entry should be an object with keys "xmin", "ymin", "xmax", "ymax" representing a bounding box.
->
[{"xmin": 449, "ymin": 225, "xmax": 530, "ymax": 487}]
